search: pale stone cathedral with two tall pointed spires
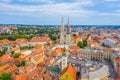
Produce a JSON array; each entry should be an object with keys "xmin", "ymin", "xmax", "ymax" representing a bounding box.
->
[{"xmin": 60, "ymin": 18, "xmax": 71, "ymax": 45}]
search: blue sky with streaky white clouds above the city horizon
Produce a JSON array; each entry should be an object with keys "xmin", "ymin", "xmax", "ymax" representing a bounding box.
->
[{"xmin": 0, "ymin": 0, "xmax": 120, "ymax": 25}]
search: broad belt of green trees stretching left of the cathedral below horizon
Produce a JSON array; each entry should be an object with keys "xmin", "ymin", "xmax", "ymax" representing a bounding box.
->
[{"xmin": 0, "ymin": 27, "xmax": 59, "ymax": 40}]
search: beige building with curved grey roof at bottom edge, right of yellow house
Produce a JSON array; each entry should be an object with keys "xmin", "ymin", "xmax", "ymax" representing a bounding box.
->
[{"xmin": 81, "ymin": 65, "xmax": 108, "ymax": 80}]
